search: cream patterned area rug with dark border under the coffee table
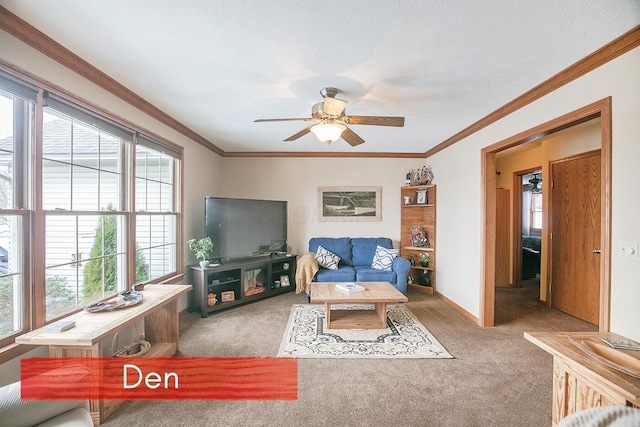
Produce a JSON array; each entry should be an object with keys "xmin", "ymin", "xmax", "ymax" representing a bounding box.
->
[{"xmin": 278, "ymin": 304, "xmax": 453, "ymax": 359}]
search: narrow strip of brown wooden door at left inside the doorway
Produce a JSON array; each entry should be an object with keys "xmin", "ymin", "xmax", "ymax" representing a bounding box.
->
[{"xmin": 496, "ymin": 188, "xmax": 511, "ymax": 288}]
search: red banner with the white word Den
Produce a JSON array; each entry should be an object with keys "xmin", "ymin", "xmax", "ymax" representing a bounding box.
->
[{"xmin": 21, "ymin": 357, "xmax": 298, "ymax": 400}]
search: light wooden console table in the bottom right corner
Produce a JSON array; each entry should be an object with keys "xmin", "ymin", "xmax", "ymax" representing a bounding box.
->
[{"xmin": 524, "ymin": 332, "xmax": 640, "ymax": 426}]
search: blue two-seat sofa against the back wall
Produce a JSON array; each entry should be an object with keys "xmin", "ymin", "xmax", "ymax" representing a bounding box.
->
[{"xmin": 309, "ymin": 237, "xmax": 411, "ymax": 294}]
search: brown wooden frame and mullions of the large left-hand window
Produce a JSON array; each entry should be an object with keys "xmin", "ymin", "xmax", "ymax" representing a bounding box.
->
[{"xmin": 0, "ymin": 65, "xmax": 184, "ymax": 352}]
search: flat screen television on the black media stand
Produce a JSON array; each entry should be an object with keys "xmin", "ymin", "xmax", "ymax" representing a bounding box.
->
[{"xmin": 204, "ymin": 197, "xmax": 287, "ymax": 262}]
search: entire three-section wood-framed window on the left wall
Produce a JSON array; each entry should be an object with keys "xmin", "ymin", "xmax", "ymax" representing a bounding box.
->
[{"xmin": 0, "ymin": 73, "xmax": 182, "ymax": 346}]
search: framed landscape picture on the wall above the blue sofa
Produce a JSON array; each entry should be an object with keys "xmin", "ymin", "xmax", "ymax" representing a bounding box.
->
[{"xmin": 318, "ymin": 187, "xmax": 382, "ymax": 221}]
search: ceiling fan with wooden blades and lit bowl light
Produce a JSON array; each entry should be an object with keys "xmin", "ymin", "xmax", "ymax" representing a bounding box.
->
[{"xmin": 254, "ymin": 87, "xmax": 404, "ymax": 147}]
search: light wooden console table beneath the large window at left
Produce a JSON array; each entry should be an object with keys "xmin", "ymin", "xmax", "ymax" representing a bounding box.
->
[{"xmin": 16, "ymin": 285, "xmax": 191, "ymax": 425}]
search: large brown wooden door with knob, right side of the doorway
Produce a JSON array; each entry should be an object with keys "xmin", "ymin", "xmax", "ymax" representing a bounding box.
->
[{"xmin": 549, "ymin": 150, "xmax": 601, "ymax": 325}]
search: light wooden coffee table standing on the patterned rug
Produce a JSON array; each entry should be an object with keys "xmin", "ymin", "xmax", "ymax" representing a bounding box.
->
[{"xmin": 311, "ymin": 282, "xmax": 408, "ymax": 329}]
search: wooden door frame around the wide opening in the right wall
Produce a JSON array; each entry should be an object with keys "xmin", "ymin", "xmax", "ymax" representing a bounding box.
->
[{"xmin": 478, "ymin": 97, "xmax": 612, "ymax": 332}]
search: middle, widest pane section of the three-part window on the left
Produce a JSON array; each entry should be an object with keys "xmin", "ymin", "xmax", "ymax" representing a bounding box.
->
[{"xmin": 42, "ymin": 104, "xmax": 133, "ymax": 320}]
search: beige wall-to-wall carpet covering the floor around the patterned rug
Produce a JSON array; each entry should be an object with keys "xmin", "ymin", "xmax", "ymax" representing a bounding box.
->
[{"xmin": 101, "ymin": 287, "xmax": 598, "ymax": 427}]
